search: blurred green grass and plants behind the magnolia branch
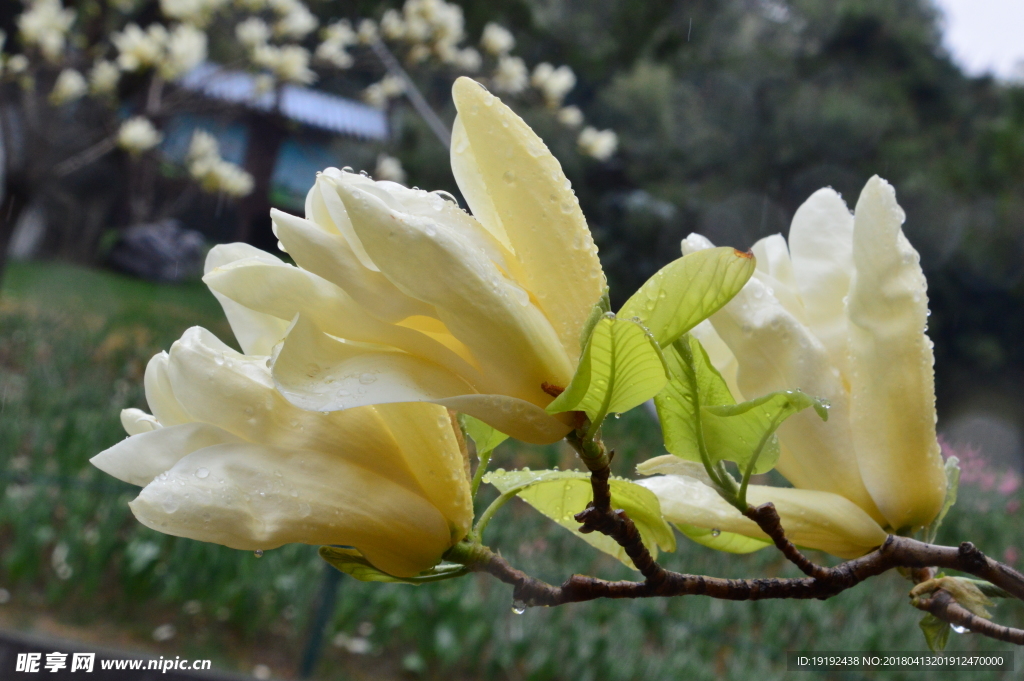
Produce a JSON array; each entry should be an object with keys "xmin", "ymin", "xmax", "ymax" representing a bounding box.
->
[{"xmin": 0, "ymin": 263, "xmax": 1024, "ymax": 681}]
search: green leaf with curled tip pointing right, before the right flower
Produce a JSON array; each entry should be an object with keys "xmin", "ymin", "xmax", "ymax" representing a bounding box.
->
[{"xmin": 700, "ymin": 390, "xmax": 828, "ymax": 473}]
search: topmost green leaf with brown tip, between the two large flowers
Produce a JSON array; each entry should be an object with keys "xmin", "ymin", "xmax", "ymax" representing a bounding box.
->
[{"xmin": 618, "ymin": 248, "xmax": 756, "ymax": 347}]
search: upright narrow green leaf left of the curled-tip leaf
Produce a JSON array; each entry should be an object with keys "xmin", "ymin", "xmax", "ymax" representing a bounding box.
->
[{"xmin": 654, "ymin": 336, "xmax": 736, "ymax": 463}]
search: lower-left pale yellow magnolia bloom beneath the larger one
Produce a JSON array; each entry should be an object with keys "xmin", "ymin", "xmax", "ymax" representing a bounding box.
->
[{"xmin": 92, "ymin": 245, "xmax": 473, "ymax": 577}]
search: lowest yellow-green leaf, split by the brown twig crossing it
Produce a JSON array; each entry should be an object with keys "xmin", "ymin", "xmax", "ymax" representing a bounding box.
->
[{"xmin": 484, "ymin": 470, "xmax": 676, "ymax": 567}]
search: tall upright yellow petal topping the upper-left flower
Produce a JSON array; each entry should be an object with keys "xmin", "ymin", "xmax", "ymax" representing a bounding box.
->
[{"xmin": 452, "ymin": 78, "xmax": 606, "ymax": 364}]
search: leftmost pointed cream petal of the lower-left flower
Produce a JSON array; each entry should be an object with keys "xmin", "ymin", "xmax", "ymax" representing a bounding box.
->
[{"xmin": 89, "ymin": 423, "xmax": 242, "ymax": 487}]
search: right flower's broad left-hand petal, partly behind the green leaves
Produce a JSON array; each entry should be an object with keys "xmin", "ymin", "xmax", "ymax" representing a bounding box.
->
[{"xmin": 684, "ymin": 232, "xmax": 883, "ymax": 521}]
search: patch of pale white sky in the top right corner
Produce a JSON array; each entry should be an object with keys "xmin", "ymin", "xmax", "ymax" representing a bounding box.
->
[{"xmin": 933, "ymin": 0, "xmax": 1024, "ymax": 79}]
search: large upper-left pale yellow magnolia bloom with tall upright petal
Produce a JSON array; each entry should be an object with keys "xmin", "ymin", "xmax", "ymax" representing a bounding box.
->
[{"xmin": 205, "ymin": 78, "xmax": 605, "ymax": 443}]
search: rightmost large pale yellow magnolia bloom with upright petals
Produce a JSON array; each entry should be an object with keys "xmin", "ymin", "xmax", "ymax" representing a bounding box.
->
[{"xmin": 644, "ymin": 176, "xmax": 946, "ymax": 557}]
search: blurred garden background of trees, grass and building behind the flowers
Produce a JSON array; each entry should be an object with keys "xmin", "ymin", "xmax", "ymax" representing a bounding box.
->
[{"xmin": 0, "ymin": 0, "xmax": 1024, "ymax": 681}]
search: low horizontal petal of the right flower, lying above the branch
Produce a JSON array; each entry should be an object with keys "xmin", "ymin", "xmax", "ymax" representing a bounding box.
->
[{"xmin": 638, "ymin": 475, "xmax": 887, "ymax": 558}]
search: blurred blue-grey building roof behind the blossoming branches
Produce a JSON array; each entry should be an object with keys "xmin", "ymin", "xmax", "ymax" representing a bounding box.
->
[{"xmin": 179, "ymin": 61, "xmax": 388, "ymax": 139}]
